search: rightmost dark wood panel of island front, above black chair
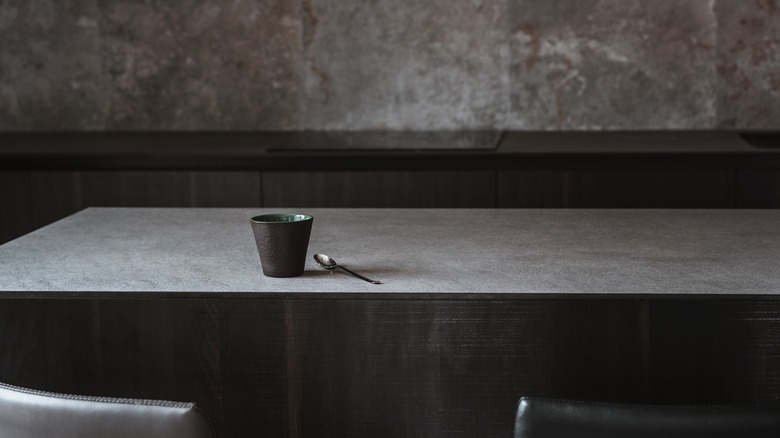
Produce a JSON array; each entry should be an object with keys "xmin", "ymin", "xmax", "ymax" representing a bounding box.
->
[{"xmin": 646, "ymin": 300, "xmax": 780, "ymax": 403}]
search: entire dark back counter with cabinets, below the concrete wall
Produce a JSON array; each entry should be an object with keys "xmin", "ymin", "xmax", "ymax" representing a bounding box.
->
[{"xmin": 0, "ymin": 131, "xmax": 780, "ymax": 243}]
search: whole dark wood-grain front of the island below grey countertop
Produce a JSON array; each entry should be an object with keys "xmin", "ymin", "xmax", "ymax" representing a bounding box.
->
[{"xmin": 0, "ymin": 297, "xmax": 780, "ymax": 438}]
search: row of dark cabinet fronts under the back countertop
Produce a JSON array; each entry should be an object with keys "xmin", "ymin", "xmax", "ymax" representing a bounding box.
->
[{"xmin": 0, "ymin": 170, "xmax": 780, "ymax": 243}]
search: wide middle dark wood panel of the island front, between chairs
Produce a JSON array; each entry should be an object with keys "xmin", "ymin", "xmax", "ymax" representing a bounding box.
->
[{"xmin": 290, "ymin": 300, "xmax": 646, "ymax": 437}]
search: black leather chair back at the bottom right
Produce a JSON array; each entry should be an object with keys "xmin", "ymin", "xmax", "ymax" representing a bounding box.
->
[{"xmin": 515, "ymin": 397, "xmax": 780, "ymax": 438}]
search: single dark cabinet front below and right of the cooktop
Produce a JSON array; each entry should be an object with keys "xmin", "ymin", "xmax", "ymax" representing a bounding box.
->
[{"xmin": 498, "ymin": 170, "xmax": 735, "ymax": 208}]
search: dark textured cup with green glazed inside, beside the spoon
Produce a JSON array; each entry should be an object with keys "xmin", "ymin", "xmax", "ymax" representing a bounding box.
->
[{"xmin": 251, "ymin": 213, "xmax": 314, "ymax": 277}]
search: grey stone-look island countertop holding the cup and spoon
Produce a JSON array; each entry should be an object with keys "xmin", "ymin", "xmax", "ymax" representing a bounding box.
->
[{"xmin": 0, "ymin": 208, "xmax": 780, "ymax": 297}]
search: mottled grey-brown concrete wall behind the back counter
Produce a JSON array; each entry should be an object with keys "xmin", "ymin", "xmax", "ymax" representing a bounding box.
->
[{"xmin": 0, "ymin": 0, "xmax": 780, "ymax": 130}]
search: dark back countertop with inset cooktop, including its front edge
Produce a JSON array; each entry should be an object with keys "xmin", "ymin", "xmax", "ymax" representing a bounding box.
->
[{"xmin": 0, "ymin": 131, "xmax": 780, "ymax": 171}]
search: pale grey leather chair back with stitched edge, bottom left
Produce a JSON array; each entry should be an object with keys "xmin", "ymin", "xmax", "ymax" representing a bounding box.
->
[{"xmin": 0, "ymin": 383, "xmax": 216, "ymax": 438}]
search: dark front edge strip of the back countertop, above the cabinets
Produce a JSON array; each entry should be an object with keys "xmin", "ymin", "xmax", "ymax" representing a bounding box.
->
[{"xmin": 6, "ymin": 151, "xmax": 780, "ymax": 171}]
